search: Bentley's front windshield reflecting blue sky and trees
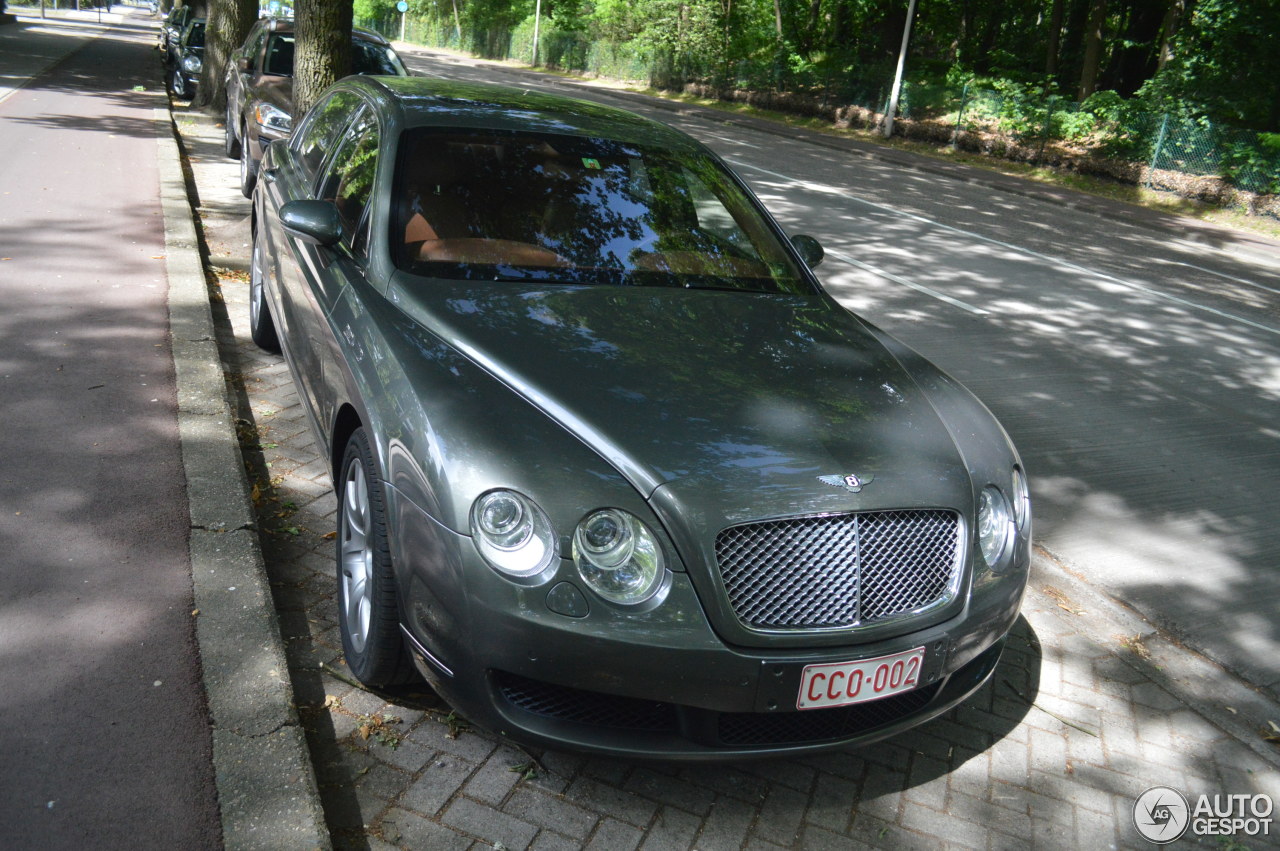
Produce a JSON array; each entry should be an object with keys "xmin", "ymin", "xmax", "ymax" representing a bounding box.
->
[{"xmin": 392, "ymin": 128, "xmax": 813, "ymax": 293}]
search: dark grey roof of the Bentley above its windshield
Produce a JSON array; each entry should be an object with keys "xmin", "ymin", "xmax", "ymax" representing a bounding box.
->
[{"xmin": 347, "ymin": 77, "xmax": 705, "ymax": 152}]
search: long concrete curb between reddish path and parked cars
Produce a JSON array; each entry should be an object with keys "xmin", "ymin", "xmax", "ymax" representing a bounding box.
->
[{"xmin": 155, "ymin": 109, "xmax": 332, "ymax": 850}]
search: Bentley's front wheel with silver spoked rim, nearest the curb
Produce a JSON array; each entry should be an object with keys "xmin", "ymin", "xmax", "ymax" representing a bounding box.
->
[{"xmin": 337, "ymin": 427, "xmax": 416, "ymax": 688}]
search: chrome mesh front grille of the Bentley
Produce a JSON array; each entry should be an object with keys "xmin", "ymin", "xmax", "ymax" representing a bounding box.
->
[{"xmin": 716, "ymin": 511, "xmax": 960, "ymax": 628}]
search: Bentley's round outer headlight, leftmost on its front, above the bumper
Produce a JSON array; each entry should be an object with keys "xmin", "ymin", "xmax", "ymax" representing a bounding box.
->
[{"xmin": 471, "ymin": 490, "xmax": 557, "ymax": 577}]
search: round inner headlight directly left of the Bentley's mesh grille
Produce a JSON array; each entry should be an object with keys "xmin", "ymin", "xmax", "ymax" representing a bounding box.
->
[{"xmin": 573, "ymin": 508, "xmax": 666, "ymax": 604}]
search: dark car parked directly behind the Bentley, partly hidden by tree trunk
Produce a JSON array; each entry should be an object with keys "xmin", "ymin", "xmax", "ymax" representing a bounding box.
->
[{"xmin": 227, "ymin": 18, "xmax": 408, "ymax": 198}]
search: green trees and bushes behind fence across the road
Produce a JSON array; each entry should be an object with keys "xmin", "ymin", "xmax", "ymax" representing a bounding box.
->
[{"xmin": 373, "ymin": 0, "xmax": 1280, "ymax": 202}]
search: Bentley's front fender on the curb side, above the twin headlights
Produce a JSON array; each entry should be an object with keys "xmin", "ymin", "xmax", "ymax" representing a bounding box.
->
[{"xmin": 329, "ymin": 282, "xmax": 657, "ymax": 553}]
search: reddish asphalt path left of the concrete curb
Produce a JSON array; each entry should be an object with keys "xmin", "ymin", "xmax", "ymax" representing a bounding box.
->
[{"xmin": 0, "ymin": 14, "xmax": 221, "ymax": 848}]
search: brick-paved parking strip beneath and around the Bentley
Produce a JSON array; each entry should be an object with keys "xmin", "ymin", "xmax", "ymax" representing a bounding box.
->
[{"xmin": 179, "ymin": 112, "xmax": 1280, "ymax": 851}]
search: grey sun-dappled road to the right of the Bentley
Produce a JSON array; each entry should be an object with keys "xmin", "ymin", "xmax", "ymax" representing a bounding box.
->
[{"xmin": 408, "ymin": 52, "xmax": 1280, "ymax": 694}]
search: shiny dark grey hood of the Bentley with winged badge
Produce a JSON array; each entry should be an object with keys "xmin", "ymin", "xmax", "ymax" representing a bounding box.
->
[{"xmin": 390, "ymin": 276, "xmax": 973, "ymax": 530}]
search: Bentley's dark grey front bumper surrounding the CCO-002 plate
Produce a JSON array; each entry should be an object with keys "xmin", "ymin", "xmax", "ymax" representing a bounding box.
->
[{"xmin": 389, "ymin": 491, "xmax": 1025, "ymax": 760}]
